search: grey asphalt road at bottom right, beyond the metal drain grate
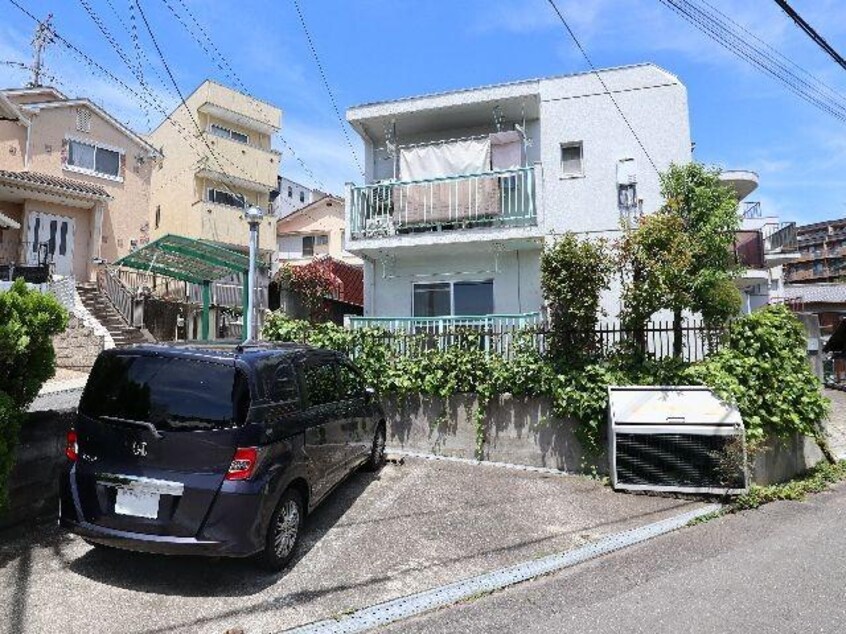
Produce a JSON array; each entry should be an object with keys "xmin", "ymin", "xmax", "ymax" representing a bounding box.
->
[{"xmin": 387, "ymin": 485, "xmax": 846, "ymax": 634}]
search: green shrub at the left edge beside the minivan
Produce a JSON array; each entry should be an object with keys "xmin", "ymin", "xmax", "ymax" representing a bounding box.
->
[{"xmin": 0, "ymin": 279, "xmax": 67, "ymax": 507}]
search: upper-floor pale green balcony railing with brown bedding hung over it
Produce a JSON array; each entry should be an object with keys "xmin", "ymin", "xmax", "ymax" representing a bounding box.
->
[{"xmin": 350, "ymin": 167, "xmax": 537, "ymax": 240}]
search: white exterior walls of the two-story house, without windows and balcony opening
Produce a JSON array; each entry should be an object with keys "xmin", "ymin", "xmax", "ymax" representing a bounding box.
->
[{"xmin": 347, "ymin": 64, "xmax": 691, "ymax": 317}]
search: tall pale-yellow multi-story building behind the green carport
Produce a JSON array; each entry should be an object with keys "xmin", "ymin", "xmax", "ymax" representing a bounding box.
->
[{"xmin": 148, "ymin": 80, "xmax": 282, "ymax": 254}]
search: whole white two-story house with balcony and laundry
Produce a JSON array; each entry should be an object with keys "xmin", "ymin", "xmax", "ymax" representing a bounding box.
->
[{"xmin": 345, "ymin": 64, "xmax": 691, "ymax": 323}]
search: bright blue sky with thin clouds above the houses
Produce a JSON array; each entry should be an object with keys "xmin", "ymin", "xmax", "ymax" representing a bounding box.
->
[{"xmin": 0, "ymin": 0, "xmax": 846, "ymax": 222}]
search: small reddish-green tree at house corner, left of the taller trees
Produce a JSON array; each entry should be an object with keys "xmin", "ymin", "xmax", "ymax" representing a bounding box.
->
[{"xmin": 541, "ymin": 232, "xmax": 613, "ymax": 360}]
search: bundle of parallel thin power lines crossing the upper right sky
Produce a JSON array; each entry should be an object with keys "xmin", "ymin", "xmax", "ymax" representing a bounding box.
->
[{"xmin": 659, "ymin": 0, "xmax": 846, "ymax": 121}]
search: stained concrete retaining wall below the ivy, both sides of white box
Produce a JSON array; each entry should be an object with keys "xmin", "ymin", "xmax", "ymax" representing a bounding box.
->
[{"xmin": 384, "ymin": 394, "xmax": 823, "ymax": 484}]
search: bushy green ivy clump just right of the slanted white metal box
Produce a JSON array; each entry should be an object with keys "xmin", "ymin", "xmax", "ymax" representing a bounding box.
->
[{"xmin": 686, "ymin": 306, "xmax": 829, "ymax": 441}]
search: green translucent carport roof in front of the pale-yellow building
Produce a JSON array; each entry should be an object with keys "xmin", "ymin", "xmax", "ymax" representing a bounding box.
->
[{"xmin": 115, "ymin": 234, "xmax": 250, "ymax": 284}]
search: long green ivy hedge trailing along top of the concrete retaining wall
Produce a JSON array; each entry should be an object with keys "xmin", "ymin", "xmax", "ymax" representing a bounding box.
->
[{"xmin": 263, "ymin": 307, "xmax": 827, "ymax": 455}]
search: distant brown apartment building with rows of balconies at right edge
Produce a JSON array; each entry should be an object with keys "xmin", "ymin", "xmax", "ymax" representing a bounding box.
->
[{"xmin": 787, "ymin": 218, "xmax": 846, "ymax": 284}]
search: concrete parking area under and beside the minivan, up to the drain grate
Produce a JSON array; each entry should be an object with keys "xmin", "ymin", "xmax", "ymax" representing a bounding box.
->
[{"xmin": 0, "ymin": 459, "xmax": 698, "ymax": 634}]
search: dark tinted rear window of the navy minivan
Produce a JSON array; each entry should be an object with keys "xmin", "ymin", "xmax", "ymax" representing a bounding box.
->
[{"xmin": 79, "ymin": 355, "xmax": 249, "ymax": 431}]
